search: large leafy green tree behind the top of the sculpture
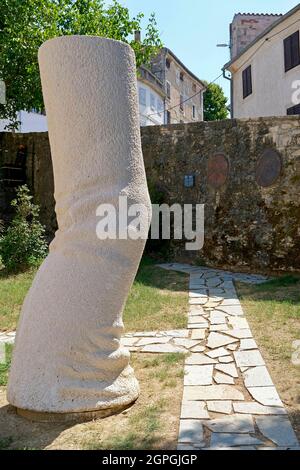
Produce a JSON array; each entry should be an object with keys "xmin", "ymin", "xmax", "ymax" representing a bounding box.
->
[{"xmin": 0, "ymin": 0, "xmax": 162, "ymax": 127}]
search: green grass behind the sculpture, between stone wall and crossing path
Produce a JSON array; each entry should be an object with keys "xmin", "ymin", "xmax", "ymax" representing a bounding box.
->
[{"xmin": 0, "ymin": 257, "xmax": 188, "ymax": 331}]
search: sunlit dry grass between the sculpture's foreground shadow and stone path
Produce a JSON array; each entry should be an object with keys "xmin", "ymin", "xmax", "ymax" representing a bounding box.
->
[{"xmin": 83, "ymin": 354, "xmax": 185, "ymax": 450}]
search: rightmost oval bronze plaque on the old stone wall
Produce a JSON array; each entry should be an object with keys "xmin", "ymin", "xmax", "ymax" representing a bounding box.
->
[{"xmin": 255, "ymin": 149, "xmax": 282, "ymax": 188}]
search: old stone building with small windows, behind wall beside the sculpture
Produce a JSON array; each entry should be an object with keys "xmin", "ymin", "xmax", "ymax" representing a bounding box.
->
[{"xmin": 151, "ymin": 47, "xmax": 205, "ymax": 124}]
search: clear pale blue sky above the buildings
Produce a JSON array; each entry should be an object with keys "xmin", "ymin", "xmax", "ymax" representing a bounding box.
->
[{"xmin": 119, "ymin": 0, "xmax": 298, "ymax": 96}]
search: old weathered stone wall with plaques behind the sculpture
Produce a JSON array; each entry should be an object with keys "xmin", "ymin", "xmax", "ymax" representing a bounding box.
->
[{"xmin": 0, "ymin": 117, "xmax": 300, "ymax": 271}]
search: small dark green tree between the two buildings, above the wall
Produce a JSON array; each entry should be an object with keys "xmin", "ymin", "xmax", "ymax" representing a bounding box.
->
[{"xmin": 204, "ymin": 82, "xmax": 228, "ymax": 121}]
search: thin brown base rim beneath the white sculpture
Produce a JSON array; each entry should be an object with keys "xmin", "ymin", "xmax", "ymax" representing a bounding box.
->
[{"xmin": 15, "ymin": 401, "xmax": 135, "ymax": 424}]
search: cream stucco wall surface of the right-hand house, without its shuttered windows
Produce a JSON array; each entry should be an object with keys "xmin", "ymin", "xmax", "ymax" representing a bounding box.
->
[{"xmin": 231, "ymin": 11, "xmax": 300, "ymax": 118}]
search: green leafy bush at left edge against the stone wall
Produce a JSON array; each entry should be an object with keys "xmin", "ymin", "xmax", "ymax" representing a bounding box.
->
[{"xmin": 0, "ymin": 185, "xmax": 48, "ymax": 271}]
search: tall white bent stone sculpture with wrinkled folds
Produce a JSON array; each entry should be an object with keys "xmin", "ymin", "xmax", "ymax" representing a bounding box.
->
[{"xmin": 8, "ymin": 36, "xmax": 150, "ymax": 420}]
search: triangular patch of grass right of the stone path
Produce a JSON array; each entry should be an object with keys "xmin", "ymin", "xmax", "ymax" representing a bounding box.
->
[{"xmin": 237, "ymin": 275, "xmax": 300, "ymax": 439}]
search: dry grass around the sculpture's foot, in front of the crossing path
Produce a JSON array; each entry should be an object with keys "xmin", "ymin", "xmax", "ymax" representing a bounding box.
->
[{"xmin": 0, "ymin": 354, "xmax": 184, "ymax": 450}]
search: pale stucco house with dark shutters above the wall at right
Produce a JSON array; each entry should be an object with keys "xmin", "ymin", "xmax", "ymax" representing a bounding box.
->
[{"xmin": 224, "ymin": 4, "xmax": 300, "ymax": 118}]
